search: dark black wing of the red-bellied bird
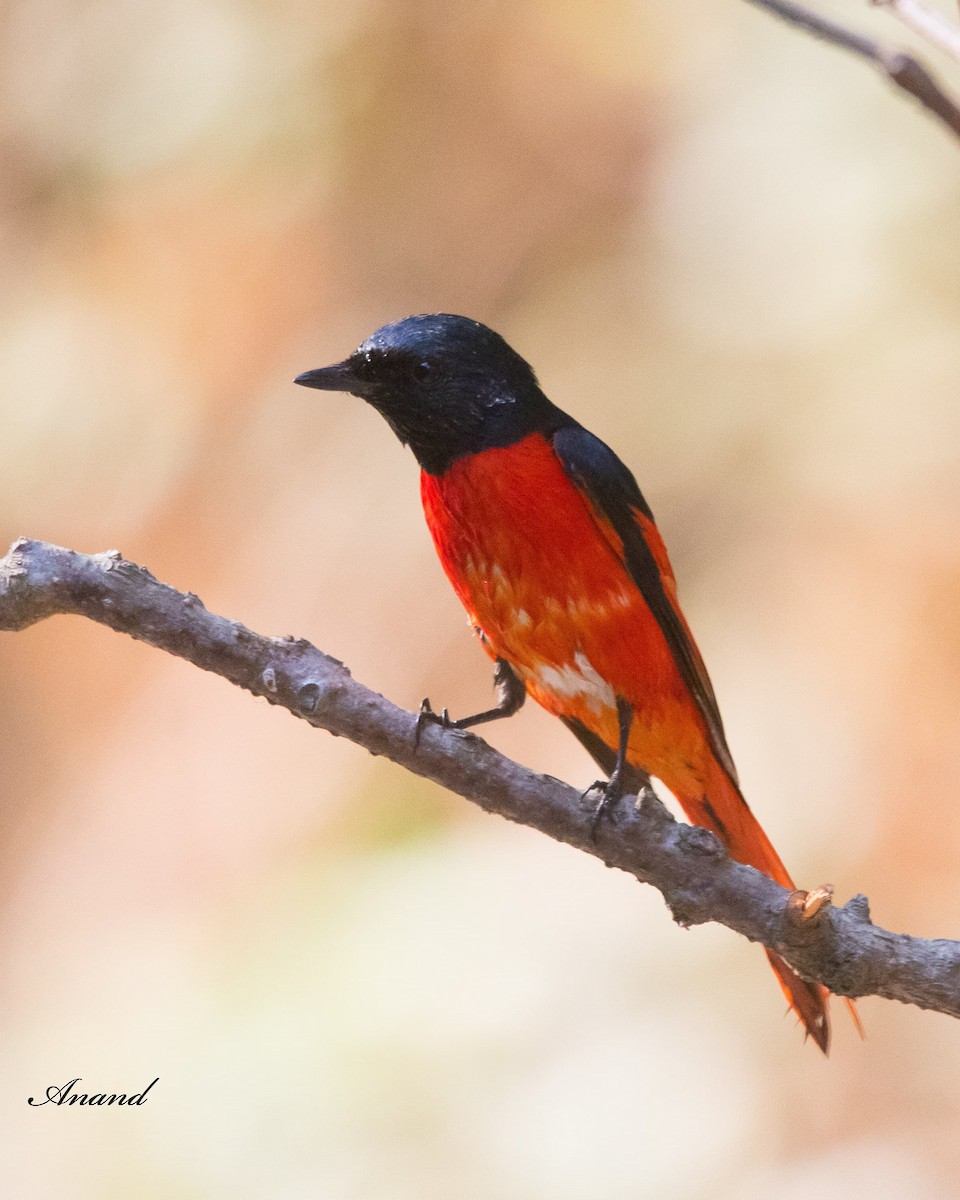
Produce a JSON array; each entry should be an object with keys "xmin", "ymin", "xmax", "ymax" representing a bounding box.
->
[{"xmin": 553, "ymin": 424, "xmax": 737, "ymax": 784}]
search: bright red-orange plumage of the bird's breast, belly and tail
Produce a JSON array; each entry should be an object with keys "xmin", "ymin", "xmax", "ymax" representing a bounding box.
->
[{"xmin": 421, "ymin": 433, "xmax": 829, "ymax": 1050}]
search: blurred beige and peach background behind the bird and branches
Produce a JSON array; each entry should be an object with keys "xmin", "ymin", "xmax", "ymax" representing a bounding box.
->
[{"xmin": 0, "ymin": 0, "xmax": 960, "ymax": 1200}]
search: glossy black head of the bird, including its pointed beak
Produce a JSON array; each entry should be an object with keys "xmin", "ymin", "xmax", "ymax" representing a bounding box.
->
[{"xmin": 295, "ymin": 313, "xmax": 568, "ymax": 475}]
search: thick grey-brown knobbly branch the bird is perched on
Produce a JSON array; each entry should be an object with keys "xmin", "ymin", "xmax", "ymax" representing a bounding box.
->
[{"xmin": 0, "ymin": 539, "xmax": 960, "ymax": 1016}]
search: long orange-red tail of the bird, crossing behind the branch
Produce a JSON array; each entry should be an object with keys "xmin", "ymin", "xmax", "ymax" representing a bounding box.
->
[{"xmin": 674, "ymin": 762, "xmax": 835, "ymax": 1054}]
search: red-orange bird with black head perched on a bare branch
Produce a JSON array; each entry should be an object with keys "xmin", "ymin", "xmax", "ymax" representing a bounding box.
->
[{"xmin": 295, "ymin": 313, "xmax": 856, "ymax": 1054}]
